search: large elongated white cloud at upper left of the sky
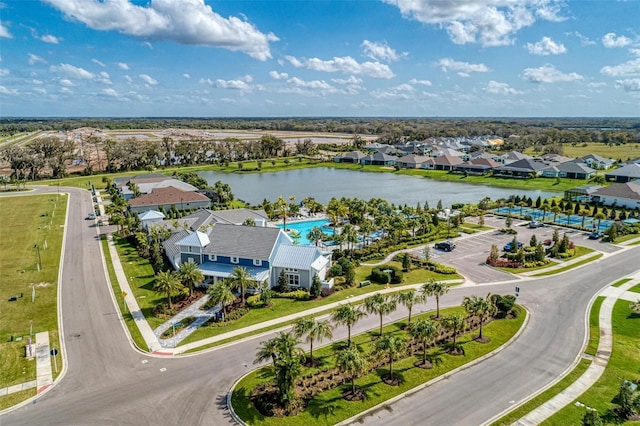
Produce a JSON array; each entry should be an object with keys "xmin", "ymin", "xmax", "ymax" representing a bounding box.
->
[{"xmin": 45, "ymin": 0, "xmax": 279, "ymax": 61}]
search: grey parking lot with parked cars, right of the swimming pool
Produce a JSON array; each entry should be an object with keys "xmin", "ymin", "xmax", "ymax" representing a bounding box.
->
[{"xmin": 416, "ymin": 215, "xmax": 620, "ymax": 284}]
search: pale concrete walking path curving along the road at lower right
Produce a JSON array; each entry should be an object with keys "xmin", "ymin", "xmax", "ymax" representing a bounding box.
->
[{"xmin": 513, "ymin": 272, "xmax": 640, "ymax": 426}]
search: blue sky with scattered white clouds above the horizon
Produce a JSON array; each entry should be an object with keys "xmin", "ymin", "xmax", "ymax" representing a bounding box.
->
[{"xmin": 0, "ymin": 0, "xmax": 640, "ymax": 117}]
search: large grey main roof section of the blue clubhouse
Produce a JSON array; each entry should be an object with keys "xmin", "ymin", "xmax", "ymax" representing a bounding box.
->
[{"xmin": 204, "ymin": 223, "xmax": 291, "ymax": 259}]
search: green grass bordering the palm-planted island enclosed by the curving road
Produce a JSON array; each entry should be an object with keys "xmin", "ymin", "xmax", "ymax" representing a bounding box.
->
[{"xmin": 231, "ymin": 308, "xmax": 526, "ymax": 426}]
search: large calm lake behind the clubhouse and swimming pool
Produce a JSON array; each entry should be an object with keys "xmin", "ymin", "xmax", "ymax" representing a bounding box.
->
[{"xmin": 198, "ymin": 167, "xmax": 558, "ymax": 207}]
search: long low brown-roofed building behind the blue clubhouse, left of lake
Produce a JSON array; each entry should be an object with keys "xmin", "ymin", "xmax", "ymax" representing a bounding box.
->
[{"xmin": 129, "ymin": 186, "xmax": 211, "ymax": 213}]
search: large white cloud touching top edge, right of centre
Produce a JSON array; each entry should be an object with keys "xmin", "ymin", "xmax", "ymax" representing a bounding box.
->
[{"xmin": 383, "ymin": 0, "xmax": 565, "ymax": 47}]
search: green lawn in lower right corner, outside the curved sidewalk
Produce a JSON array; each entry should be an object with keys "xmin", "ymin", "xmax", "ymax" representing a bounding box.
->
[{"xmin": 542, "ymin": 300, "xmax": 640, "ymax": 425}]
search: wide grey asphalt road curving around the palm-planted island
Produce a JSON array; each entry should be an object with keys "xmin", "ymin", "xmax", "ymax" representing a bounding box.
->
[{"xmin": 0, "ymin": 188, "xmax": 638, "ymax": 426}]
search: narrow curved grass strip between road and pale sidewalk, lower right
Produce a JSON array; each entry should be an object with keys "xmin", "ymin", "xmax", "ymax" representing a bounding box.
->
[{"xmin": 491, "ymin": 297, "xmax": 605, "ymax": 426}]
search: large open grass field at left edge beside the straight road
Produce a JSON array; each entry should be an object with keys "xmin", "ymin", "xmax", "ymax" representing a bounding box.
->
[{"xmin": 0, "ymin": 194, "xmax": 67, "ymax": 405}]
